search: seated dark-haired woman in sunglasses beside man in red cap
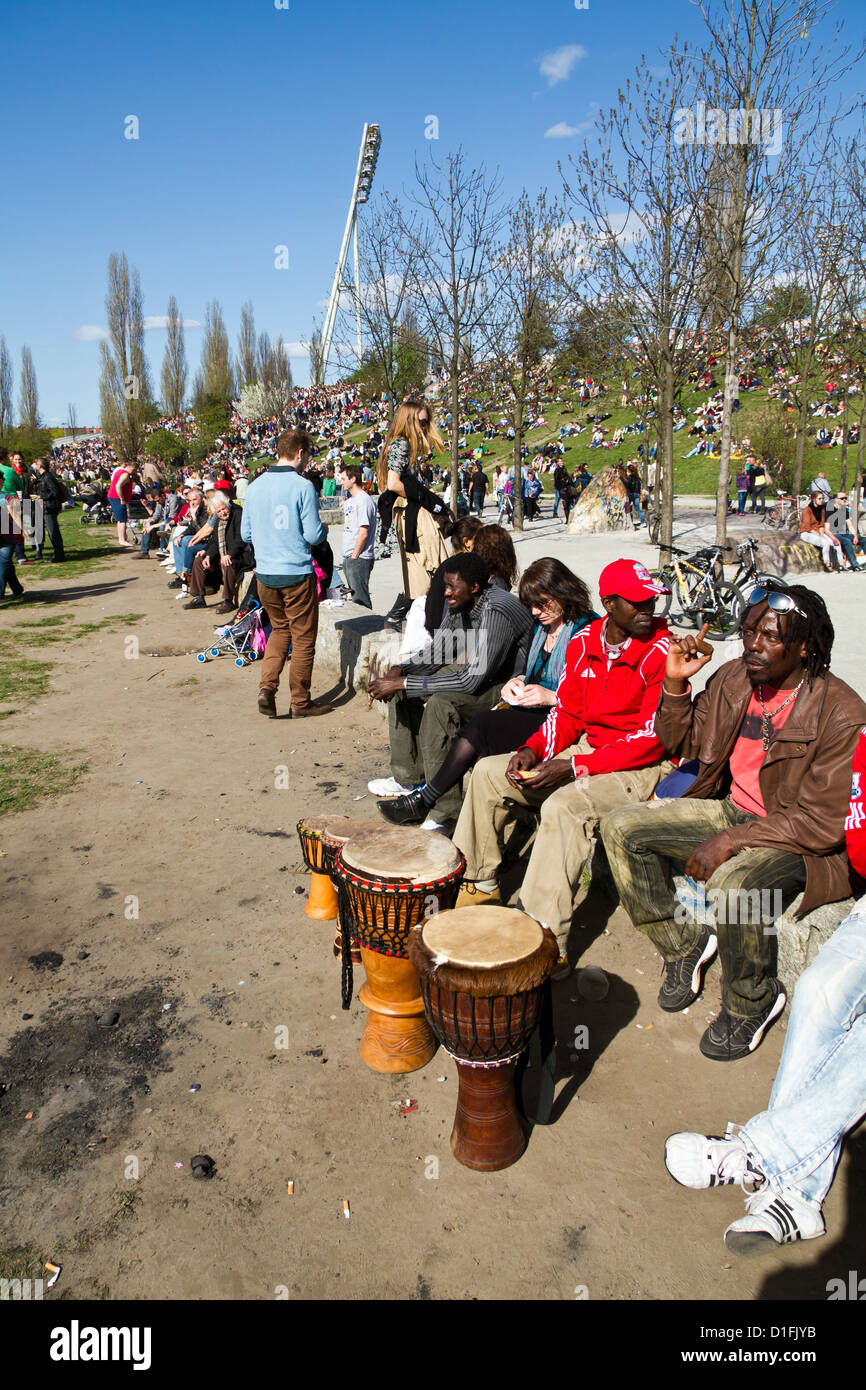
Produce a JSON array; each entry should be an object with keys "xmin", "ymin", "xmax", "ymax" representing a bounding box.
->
[{"xmin": 377, "ymin": 557, "xmax": 599, "ymax": 826}]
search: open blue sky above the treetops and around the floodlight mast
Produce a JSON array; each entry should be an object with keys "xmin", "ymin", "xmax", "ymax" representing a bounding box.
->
[{"xmin": 0, "ymin": 0, "xmax": 862, "ymax": 424}]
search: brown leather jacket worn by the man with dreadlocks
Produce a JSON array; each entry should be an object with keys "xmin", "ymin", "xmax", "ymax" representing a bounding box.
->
[{"xmin": 656, "ymin": 659, "xmax": 866, "ymax": 917}]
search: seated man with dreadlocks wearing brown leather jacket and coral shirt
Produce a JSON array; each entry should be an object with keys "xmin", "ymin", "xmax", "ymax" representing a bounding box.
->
[{"xmin": 601, "ymin": 584, "xmax": 866, "ymax": 1062}]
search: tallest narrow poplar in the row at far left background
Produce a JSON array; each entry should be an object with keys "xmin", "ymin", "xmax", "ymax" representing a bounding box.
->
[{"xmin": 99, "ymin": 253, "xmax": 153, "ymax": 460}]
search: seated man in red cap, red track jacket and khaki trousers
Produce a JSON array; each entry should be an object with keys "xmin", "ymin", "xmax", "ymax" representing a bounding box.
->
[{"xmin": 453, "ymin": 560, "xmax": 671, "ymax": 969}]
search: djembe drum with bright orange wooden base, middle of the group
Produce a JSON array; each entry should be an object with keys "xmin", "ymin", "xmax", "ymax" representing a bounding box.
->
[{"xmin": 335, "ymin": 828, "xmax": 466, "ymax": 1072}]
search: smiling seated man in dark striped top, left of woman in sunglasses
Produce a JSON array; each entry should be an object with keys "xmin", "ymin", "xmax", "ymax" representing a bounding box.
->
[{"xmin": 368, "ymin": 552, "xmax": 532, "ymax": 830}]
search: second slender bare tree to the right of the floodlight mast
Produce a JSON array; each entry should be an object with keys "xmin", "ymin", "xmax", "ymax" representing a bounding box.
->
[{"xmin": 481, "ymin": 189, "xmax": 561, "ymax": 531}]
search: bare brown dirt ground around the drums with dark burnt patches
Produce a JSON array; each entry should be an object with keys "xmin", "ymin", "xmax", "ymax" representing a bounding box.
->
[{"xmin": 0, "ymin": 556, "xmax": 866, "ymax": 1301}]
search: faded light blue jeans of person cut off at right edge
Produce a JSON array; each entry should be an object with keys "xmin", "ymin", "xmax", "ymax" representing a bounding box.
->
[{"xmin": 741, "ymin": 897, "xmax": 866, "ymax": 1207}]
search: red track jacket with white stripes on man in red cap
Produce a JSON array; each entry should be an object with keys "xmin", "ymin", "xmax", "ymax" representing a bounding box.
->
[{"xmin": 524, "ymin": 617, "xmax": 669, "ymax": 777}]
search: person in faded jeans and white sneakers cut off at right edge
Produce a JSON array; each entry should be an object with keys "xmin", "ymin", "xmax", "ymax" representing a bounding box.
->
[{"xmin": 664, "ymin": 730, "xmax": 866, "ymax": 1256}]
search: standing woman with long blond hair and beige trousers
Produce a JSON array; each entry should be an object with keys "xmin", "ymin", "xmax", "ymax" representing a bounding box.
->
[{"xmin": 378, "ymin": 400, "xmax": 448, "ymax": 627}]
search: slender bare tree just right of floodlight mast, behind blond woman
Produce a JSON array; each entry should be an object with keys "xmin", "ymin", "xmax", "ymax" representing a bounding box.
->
[{"xmin": 393, "ymin": 149, "xmax": 503, "ymax": 502}]
